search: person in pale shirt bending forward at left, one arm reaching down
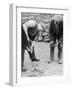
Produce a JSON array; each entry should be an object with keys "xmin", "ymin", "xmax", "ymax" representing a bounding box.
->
[{"xmin": 21, "ymin": 20, "xmax": 39, "ymax": 70}]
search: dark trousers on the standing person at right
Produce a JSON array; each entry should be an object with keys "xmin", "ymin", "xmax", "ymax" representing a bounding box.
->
[{"xmin": 49, "ymin": 20, "xmax": 63, "ymax": 60}]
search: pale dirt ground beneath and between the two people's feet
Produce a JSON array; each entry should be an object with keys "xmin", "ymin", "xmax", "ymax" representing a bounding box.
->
[{"xmin": 21, "ymin": 42, "xmax": 63, "ymax": 77}]
